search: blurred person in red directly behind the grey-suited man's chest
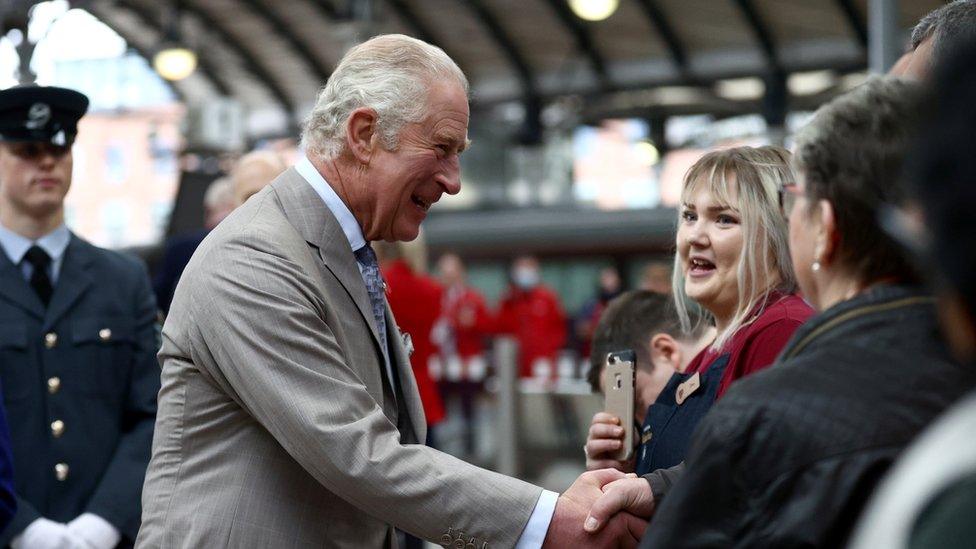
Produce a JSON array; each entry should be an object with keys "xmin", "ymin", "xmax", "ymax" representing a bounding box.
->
[{"xmin": 376, "ymin": 242, "xmax": 444, "ymax": 432}]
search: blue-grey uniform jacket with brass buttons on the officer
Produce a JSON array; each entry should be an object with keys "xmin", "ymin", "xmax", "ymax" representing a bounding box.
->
[{"xmin": 0, "ymin": 235, "xmax": 159, "ymax": 547}]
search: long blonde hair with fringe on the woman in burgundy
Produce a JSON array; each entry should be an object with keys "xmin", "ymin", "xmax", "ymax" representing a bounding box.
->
[{"xmin": 671, "ymin": 146, "xmax": 796, "ymax": 350}]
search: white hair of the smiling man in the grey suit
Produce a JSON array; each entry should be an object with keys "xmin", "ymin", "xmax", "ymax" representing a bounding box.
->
[{"xmin": 302, "ymin": 34, "xmax": 468, "ymax": 158}]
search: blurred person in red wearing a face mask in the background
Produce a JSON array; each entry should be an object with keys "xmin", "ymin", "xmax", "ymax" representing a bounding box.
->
[{"xmin": 498, "ymin": 256, "xmax": 566, "ymax": 379}]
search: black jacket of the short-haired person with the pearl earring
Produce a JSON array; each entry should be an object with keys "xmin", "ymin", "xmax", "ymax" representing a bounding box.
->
[{"xmin": 641, "ymin": 286, "xmax": 976, "ymax": 549}]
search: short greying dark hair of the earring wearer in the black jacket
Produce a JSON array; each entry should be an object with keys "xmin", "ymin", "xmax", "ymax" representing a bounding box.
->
[{"xmin": 794, "ymin": 76, "xmax": 924, "ymax": 285}]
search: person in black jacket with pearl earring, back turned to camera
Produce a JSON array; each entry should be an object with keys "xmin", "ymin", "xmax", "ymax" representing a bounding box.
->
[{"xmin": 588, "ymin": 78, "xmax": 976, "ymax": 548}]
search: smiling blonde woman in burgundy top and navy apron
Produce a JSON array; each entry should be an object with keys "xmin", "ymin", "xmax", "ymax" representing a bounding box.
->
[{"xmin": 585, "ymin": 147, "xmax": 813, "ymax": 532}]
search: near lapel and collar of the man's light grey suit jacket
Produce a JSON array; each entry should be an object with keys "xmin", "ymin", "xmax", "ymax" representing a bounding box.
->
[{"xmin": 271, "ymin": 168, "xmax": 392, "ymax": 366}]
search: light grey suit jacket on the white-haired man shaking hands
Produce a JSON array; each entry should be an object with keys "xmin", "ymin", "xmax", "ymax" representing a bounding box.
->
[{"xmin": 136, "ymin": 169, "xmax": 541, "ymax": 548}]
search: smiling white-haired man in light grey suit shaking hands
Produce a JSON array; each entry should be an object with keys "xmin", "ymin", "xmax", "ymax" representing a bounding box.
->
[{"xmin": 137, "ymin": 35, "xmax": 643, "ymax": 549}]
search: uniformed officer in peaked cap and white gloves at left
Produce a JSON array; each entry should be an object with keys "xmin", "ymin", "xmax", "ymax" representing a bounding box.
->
[{"xmin": 0, "ymin": 86, "xmax": 159, "ymax": 549}]
